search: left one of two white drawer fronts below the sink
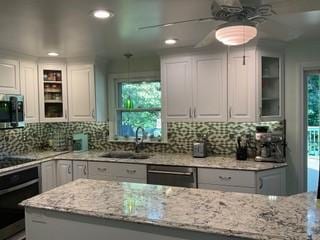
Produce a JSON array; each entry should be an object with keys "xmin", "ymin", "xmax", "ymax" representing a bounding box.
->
[{"xmin": 88, "ymin": 162, "xmax": 112, "ymax": 180}]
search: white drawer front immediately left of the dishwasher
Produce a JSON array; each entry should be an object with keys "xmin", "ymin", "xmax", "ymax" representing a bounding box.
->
[{"xmin": 112, "ymin": 163, "xmax": 147, "ymax": 179}]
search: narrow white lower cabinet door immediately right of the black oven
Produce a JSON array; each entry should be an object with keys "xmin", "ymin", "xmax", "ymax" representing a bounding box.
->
[{"xmin": 41, "ymin": 161, "xmax": 57, "ymax": 192}]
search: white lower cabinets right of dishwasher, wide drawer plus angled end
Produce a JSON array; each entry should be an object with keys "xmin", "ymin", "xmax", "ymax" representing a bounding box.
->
[{"xmin": 198, "ymin": 168, "xmax": 286, "ymax": 195}]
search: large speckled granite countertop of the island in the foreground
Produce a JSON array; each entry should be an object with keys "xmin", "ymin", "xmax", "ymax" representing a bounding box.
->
[{"xmin": 21, "ymin": 179, "xmax": 320, "ymax": 240}]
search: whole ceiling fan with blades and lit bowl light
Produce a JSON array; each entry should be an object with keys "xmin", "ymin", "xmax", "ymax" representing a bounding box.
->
[{"xmin": 139, "ymin": 0, "xmax": 276, "ymax": 48}]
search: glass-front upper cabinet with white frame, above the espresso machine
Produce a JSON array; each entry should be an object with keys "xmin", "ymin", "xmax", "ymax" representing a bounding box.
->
[{"xmin": 259, "ymin": 51, "xmax": 284, "ymax": 121}]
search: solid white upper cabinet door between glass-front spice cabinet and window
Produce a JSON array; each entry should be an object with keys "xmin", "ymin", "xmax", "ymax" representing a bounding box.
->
[{"xmin": 68, "ymin": 65, "xmax": 95, "ymax": 121}]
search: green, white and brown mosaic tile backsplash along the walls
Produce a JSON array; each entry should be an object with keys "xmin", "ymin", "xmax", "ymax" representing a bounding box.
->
[{"xmin": 0, "ymin": 122, "xmax": 283, "ymax": 155}]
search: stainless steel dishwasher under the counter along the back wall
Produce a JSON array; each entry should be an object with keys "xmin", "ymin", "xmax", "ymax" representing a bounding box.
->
[{"xmin": 147, "ymin": 165, "xmax": 197, "ymax": 188}]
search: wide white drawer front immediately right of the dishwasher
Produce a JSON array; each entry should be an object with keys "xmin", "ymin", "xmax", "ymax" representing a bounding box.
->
[{"xmin": 198, "ymin": 168, "xmax": 255, "ymax": 188}]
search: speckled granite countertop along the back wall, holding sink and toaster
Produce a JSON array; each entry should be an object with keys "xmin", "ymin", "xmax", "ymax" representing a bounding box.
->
[{"xmin": 56, "ymin": 151, "xmax": 287, "ymax": 171}]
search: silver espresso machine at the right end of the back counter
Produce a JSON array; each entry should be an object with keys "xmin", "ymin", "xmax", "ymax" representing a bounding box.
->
[{"xmin": 255, "ymin": 132, "xmax": 285, "ymax": 163}]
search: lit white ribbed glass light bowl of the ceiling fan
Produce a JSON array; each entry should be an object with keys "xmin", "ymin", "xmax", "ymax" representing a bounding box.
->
[{"xmin": 216, "ymin": 23, "xmax": 257, "ymax": 46}]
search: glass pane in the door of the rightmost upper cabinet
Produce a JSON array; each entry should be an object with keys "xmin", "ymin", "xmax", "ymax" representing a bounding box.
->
[{"xmin": 260, "ymin": 56, "xmax": 281, "ymax": 118}]
